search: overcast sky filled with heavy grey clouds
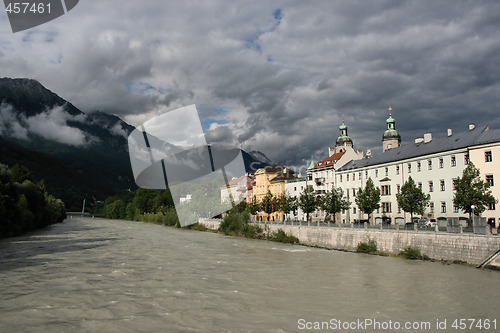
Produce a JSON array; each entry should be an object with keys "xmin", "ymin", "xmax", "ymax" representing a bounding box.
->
[{"xmin": 0, "ymin": 0, "xmax": 500, "ymax": 166}]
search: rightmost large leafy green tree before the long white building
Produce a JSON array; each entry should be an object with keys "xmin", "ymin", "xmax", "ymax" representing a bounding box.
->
[{"xmin": 453, "ymin": 162, "xmax": 498, "ymax": 224}]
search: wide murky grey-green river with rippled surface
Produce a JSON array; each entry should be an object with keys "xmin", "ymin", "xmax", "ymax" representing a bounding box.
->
[{"xmin": 0, "ymin": 218, "xmax": 500, "ymax": 332}]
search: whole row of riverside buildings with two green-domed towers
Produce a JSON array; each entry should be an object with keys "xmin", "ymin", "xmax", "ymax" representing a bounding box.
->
[{"xmin": 221, "ymin": 114, "xmax": 500, "ymax": 226}]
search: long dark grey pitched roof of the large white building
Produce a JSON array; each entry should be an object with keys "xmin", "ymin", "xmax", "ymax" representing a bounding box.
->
[{"xmin": 338, "ymin": 126, "xmax": 492, "ymax": 171}]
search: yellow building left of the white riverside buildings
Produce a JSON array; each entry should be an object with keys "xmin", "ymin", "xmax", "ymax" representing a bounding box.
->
[{"xmin": 253, "ymin": 166, "xmax": 294, "ymax": 221}]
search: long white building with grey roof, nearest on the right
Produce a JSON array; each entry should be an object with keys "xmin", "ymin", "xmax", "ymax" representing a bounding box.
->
[{"xmin": 335, "ymin": 117, "xmax": 500, "ymax": 225}]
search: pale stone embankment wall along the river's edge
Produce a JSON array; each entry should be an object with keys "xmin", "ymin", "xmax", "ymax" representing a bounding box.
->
[{"xmin": 202, "ymin": 221, "xmax": 500, "ymax": 267}]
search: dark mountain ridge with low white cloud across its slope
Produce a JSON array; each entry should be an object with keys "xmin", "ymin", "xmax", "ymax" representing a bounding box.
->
[{"xmin": 0, "ymin": 78, "xmax": 272, "ymax": 210}]
